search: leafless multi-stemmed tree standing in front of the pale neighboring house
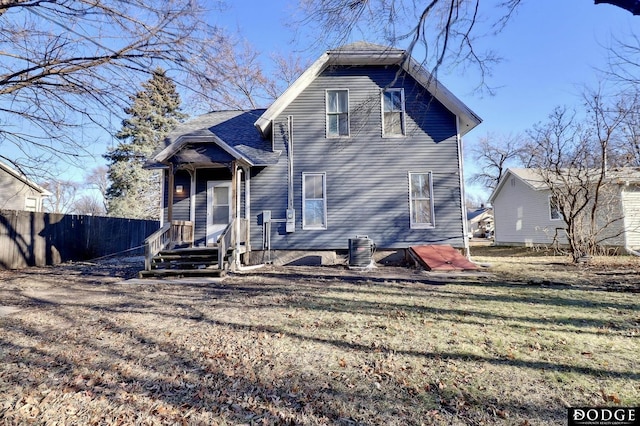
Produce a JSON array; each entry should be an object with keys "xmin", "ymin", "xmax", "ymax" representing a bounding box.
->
[{"xmin": 528, "ymin": 92, "xmax": 630, "ymax": 262}]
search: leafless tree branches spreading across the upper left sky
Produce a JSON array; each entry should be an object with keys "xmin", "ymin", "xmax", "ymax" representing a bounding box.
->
[{"xmin": 0, "ymin": 0, "xmax": 225, "ymax": 175}]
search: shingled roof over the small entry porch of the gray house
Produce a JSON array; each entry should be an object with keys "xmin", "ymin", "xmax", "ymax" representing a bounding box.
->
[{"xmin": 147, "ymin": 109, "xmax": 280, "ymax": 167}]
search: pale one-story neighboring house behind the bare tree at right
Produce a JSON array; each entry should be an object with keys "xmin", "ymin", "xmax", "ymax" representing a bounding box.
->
[{"xmin": 489, "ymin": 168, "xmax": 640, "ymax": 250}]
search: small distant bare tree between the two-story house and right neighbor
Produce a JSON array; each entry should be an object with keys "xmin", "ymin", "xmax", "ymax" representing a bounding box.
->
[{"xmin": 468, "ymin": 134, "xmax": 530, "ymax": 191}]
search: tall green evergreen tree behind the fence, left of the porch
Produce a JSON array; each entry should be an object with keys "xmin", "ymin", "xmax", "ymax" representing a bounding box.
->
[{"xmin": 104, "ymin": 68, "xmax": 186, "ymax": 219}]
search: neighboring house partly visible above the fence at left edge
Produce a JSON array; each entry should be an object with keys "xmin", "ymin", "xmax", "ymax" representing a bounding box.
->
[{"xmin": 0, "ymin": 162, "xmax": 51, "ymax": 212}]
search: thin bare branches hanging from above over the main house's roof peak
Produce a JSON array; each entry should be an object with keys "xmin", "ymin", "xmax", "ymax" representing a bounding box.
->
[{"xmin": 298, "ymin": 0, "xmax": 637, "ymax": 92}]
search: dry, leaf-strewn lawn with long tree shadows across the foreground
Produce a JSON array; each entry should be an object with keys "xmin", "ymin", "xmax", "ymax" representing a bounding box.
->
[{"xmin": 0, "ymin": 249, "xmax": 640, "ymax": 426}]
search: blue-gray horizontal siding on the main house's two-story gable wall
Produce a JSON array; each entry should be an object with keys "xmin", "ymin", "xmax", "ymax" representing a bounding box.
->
[{"xmin": 251, "ymin": 67, "xmax": 464, "ymax": 249}]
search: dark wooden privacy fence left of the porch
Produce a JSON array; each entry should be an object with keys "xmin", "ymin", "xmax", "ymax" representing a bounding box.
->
[{"xmin": 0, "ymin": 210, "xmax": 160, "ymax": 269}]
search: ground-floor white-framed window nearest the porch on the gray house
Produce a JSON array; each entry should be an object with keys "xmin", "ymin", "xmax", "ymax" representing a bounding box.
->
[{"xmin": 302, "ymin": 173, "xmax": 327, "ymax": 229}]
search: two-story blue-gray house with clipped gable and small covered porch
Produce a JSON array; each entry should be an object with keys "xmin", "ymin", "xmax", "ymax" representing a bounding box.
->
[{"xmin": 149, "ymin": 43, "xmax": 481, "ymax": 270}]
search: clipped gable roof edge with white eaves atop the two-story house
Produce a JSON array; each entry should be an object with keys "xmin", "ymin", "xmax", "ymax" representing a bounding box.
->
[{"xmin": 255, "ymin": 42, "xmax": 482, "ymax": 135}]
